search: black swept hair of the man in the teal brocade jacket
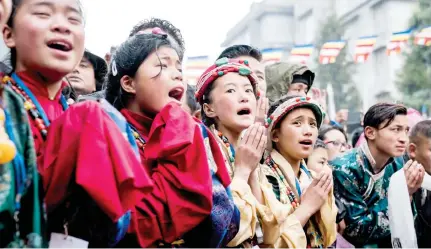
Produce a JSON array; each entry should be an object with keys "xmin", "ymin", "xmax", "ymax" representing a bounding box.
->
[{"xmin": 364, "ymin": 103, "xmax": 407, "ymax": 130}]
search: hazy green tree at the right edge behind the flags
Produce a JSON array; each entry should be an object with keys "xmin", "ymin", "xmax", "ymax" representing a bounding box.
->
[{"xmin": 396, "ymin": 0, "xmax": 431, "ymax": 110}]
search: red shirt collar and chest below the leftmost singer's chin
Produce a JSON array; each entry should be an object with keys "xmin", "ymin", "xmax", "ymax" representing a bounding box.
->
[{"xmin": 16, "ymin": 71, "xmax": 67, "ymax": 167}]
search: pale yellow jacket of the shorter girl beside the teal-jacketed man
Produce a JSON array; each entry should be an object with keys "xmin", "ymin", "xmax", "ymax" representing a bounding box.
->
[{"xmin": 262, "ymin": 150, "xmax": 337, "ymax": 248}]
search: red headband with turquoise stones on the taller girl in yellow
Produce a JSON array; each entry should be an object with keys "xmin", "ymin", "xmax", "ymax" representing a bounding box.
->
[{"xmin": 195, "ymin": 57, "xmax": 259, "ymax": 105}]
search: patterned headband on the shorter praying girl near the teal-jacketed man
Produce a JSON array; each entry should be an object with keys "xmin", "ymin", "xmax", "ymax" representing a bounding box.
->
[{"xmin": 265, "ymin": 97, "xmax": 325, "ymax": 151}]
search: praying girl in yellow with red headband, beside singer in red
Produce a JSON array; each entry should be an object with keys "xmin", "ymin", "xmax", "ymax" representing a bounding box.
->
[{"xmin": 196, "ymin": 58, "xmax": 301, "ymax": 247}]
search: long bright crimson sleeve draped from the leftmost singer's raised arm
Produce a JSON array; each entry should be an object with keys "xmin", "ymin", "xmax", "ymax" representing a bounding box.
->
[{"xmin": 40, "ymin": 101, "xmax": 152, "ymax": 221}]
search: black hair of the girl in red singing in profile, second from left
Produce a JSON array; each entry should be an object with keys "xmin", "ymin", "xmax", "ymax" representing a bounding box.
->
[{"xmin": 106, "ymin": 34, "xmax": 178, "ymax": 109}]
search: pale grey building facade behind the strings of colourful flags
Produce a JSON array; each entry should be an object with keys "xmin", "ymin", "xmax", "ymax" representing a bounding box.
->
[{"xmin": 222, "ymin": 0, "xmax": 418, "ymax": 110}]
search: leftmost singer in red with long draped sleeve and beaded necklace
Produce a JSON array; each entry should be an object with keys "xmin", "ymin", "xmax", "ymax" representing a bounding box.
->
[{"xmin": 2, "ymin": 0, "xmax": 151, "ymax": 247}]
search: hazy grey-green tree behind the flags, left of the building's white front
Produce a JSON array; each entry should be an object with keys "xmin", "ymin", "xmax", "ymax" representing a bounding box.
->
[{"xmin": 316, "ymin": 15, "xmax": 362, "ymax": 110}]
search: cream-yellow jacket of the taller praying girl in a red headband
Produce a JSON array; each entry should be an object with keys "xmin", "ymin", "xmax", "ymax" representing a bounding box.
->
[{"xmin": 216, "ymin": 130, "xmax": 305, "ymax": 248}]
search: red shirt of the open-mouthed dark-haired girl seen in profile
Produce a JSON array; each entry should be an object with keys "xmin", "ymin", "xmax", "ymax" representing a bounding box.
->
[{"xmin": 121, "ymin": 103, "xmax": 219, "ymax": 247}]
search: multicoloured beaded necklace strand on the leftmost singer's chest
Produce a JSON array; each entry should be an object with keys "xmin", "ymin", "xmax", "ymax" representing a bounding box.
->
[{"xmin": 2, "ymin": 73, "xmax": 68, "ymax": 140}]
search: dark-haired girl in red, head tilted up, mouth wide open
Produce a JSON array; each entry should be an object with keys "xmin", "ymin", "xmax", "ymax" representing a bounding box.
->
[{"xmin": 106, "ymin": 28, "xmax": 239, "ymax": 247}]
